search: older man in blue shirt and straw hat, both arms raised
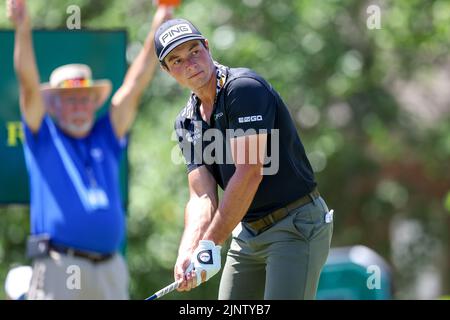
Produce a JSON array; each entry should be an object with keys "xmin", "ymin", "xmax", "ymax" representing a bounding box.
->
[{"xmin": 7, "ymin": 0, "xmax": 171, "ymax": 299}]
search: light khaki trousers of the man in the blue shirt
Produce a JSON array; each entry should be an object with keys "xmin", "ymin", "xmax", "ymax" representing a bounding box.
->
[{"xmin": 28, "ymin": 251, "xmax": 129, "ymax": 300}]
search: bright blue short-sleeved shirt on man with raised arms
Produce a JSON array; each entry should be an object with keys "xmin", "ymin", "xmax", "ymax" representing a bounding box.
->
[{"xmin": 22, "ymin": 113, "xmax": 127, "ymax": 253}]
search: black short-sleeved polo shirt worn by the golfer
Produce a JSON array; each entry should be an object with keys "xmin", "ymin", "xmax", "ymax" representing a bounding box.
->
[{"xmin": 175, "ymin": 68, "xmax": 316, "ymax": 221}]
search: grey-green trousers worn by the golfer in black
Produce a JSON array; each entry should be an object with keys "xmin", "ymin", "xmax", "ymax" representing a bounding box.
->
[{"xmin": 219, "ymin": 197, "xmax": 333, "ymax": 300}]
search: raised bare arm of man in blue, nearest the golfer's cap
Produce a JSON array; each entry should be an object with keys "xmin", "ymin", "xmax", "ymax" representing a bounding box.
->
[{"xmin": 111, "ymin": 6, "xmax": 173, "ymax": 138}]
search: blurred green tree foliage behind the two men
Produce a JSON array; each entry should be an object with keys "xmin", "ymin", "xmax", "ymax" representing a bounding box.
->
[{"xmin": 0, "ymin": 0, "xmax": 450, "ymax": 299}]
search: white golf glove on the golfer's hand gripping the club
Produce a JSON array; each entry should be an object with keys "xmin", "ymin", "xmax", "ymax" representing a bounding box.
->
[{"xmin": 189, "ymin": 240, "xmax": 222, "ymax": 286}]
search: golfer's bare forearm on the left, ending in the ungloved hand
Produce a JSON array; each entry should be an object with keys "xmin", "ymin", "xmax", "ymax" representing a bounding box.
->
[{"xmin": 174, "ymin": 166, "xmax": 218, "ymax": 291}]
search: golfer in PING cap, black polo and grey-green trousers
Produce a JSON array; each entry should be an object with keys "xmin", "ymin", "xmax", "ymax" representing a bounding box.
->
[{"xmin": 155, "ymin": 19, "xmax": 333, "ymax": 299}]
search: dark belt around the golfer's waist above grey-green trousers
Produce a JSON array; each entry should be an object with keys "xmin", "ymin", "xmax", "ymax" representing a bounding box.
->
[{"xmin": 246, "ymin": 187, "xmax": 320, "ymax": 233}]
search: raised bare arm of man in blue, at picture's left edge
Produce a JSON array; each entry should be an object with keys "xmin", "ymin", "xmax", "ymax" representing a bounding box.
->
[{"xmin": 6, "ymin": 0, "xmax": 45, "ymax": 132}]
